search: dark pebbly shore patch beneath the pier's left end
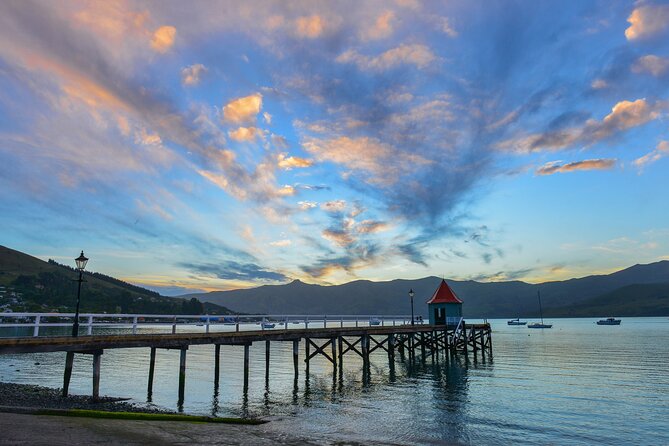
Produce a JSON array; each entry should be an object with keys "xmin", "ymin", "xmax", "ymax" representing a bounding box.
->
[{"xmin": 0, "ymin": 383, "xmax": 174, "ymax": 413}]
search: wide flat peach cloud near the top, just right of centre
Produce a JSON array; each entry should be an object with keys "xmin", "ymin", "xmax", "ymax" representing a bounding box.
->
[{"xmin": 335, "ymin": 44, "xmax": 437, "ymax": 71}]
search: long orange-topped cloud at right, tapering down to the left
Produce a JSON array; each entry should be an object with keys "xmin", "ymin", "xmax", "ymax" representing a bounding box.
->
[{"xmin": 497, "ymin": 99, "xmax": 664, "ymax": 153}]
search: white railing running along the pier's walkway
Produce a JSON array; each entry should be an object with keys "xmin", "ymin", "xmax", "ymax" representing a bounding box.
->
[{"xmin": 0, "ymin": 313, "xmax": 411, "ymax": 337}]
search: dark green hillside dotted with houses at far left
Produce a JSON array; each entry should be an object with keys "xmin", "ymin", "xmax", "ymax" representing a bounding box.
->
[{"xmin": 0, "ymin": 246, "xmax": 231, "ymax": 314}]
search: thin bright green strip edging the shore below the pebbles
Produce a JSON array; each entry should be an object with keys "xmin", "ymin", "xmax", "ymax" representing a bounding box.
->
[{"xmin": 34, "ymin": 409, "xmax": 266, "ymax": 425}]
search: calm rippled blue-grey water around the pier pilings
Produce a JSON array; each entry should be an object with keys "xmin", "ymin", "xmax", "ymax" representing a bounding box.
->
[{"xmin": 0, "ymin": 318, "xmax": 669, "ymax": 444}]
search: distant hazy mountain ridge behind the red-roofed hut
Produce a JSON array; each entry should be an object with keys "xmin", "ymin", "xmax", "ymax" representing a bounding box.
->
[{"xmin": 182, "ymin": 260, "xmax": 669, "ymax": 318}]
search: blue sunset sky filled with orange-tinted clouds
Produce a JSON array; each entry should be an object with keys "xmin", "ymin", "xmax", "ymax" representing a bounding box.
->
[{"xmin": 0, "ymin": 0, "xmax": 669, "ymax": 295}]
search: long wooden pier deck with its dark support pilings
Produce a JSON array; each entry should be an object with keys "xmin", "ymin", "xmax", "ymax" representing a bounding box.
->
[{"xmin": 0, "ymin": 320, "xmax": 492, "ymax": 402}]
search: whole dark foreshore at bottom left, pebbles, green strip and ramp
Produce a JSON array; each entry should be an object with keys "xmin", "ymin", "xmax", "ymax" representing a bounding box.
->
[{"xmin": 0, "ymin": 382, "xmax": 324, "ymax": 446}]
